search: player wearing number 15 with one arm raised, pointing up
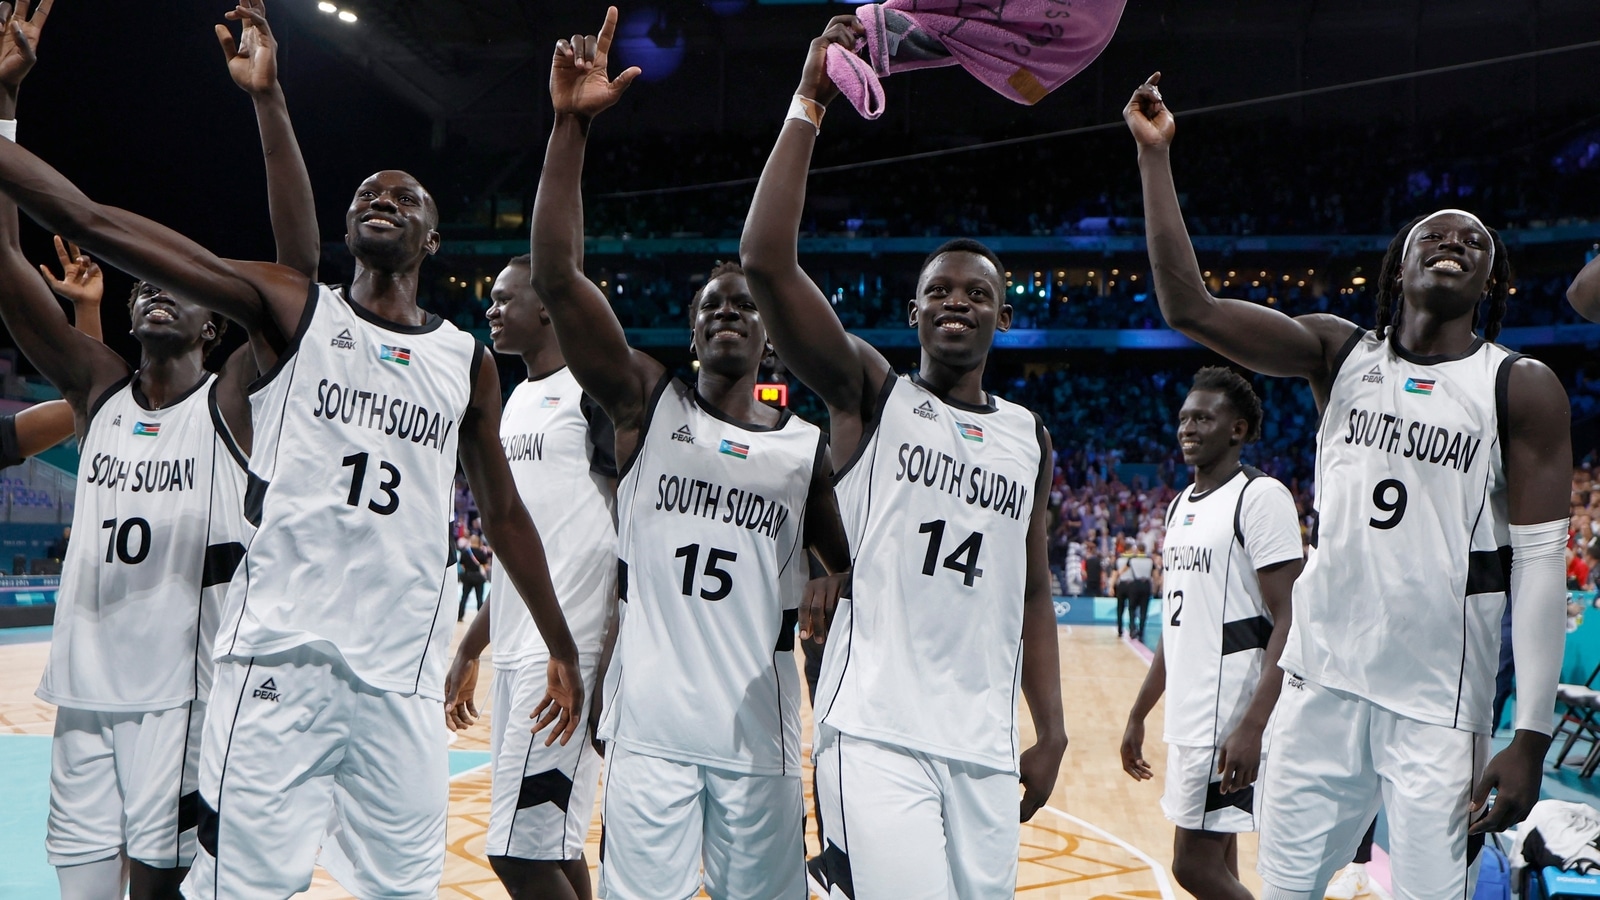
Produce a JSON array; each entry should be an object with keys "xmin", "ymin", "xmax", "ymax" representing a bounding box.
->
[{"xmin": 531, "ymin": 8, "xmax": 850, "ymax": 900}]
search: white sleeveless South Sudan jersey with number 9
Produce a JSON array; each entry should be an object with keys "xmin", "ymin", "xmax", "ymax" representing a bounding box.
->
[{"xmin": 1282, "ymin": 331, "xmax": 1517, "ymax": 732}]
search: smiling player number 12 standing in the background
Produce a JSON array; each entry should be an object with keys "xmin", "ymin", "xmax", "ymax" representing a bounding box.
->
[{"xmin": 1122, "ymin": 367, "xmax": 1302, "ymax": 900}]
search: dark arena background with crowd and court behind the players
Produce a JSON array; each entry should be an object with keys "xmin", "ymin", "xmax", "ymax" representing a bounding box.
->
[{"xmin": 0, "ymin": 0, "xmax": 1600, "ymax": 900}]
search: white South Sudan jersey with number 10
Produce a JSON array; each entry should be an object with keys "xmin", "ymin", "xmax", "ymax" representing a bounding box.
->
[{"xmin": 37, "ymin": 375, "xmax": 251, "ymax": 713}]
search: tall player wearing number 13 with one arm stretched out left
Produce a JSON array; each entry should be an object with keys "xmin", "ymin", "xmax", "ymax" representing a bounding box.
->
[{"xmin": 0, "ymin": 42, "xmax": 582, "ymax": 897}]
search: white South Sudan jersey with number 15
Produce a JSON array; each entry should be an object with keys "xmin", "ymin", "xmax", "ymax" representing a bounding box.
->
[{"xmin": 600, "ymin": 378, "xmax": 824, "ymax": 775}]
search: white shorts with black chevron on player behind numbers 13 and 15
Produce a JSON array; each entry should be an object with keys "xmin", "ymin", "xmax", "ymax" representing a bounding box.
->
[{"xmin": 483, "ymin": 655, "xmax": 600, "ymax": 860}]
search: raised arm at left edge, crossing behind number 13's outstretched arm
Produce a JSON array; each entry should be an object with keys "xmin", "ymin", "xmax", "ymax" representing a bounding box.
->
[{"xmin": 0, "ymin": 0, "xmax": 128, "ymax": 398}]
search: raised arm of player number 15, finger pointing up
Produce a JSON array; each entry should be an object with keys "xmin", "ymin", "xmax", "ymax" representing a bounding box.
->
[{"xmin": 531, "ymin": 6, "xmax": 652, "ymax": 432}]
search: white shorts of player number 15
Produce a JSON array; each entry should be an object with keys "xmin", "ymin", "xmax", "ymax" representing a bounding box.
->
[{"xmin": 600, "ymin": 741, "xmax": 806, "ymax": 900}]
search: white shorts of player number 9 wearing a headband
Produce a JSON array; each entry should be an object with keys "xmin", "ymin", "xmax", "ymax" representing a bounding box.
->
[{"xmin": 1256, "ymin": 674, "xmax": 1488, "ymax": 900}]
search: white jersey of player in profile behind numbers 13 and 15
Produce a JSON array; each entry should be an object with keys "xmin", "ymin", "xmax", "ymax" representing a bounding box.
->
[{"xmin": 490, "ymin": 368, "xmax": 616, "ymax": 669}]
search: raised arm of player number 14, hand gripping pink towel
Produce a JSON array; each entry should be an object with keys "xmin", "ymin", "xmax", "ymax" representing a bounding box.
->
[{"xmin": 739, "ymin": 16, "xmax": 891, "ymax": 432}]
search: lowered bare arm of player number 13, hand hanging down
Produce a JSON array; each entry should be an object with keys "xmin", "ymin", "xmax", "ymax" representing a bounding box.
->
[{"xmin": 458, "ymin": 354, "xmax": 584, "ymax": 745}]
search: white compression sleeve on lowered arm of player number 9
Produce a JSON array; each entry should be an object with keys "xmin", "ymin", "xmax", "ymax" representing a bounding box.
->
[{"xmin": 1510, "ymin": 519, "xmax": 1568, "ymax": 735}]
